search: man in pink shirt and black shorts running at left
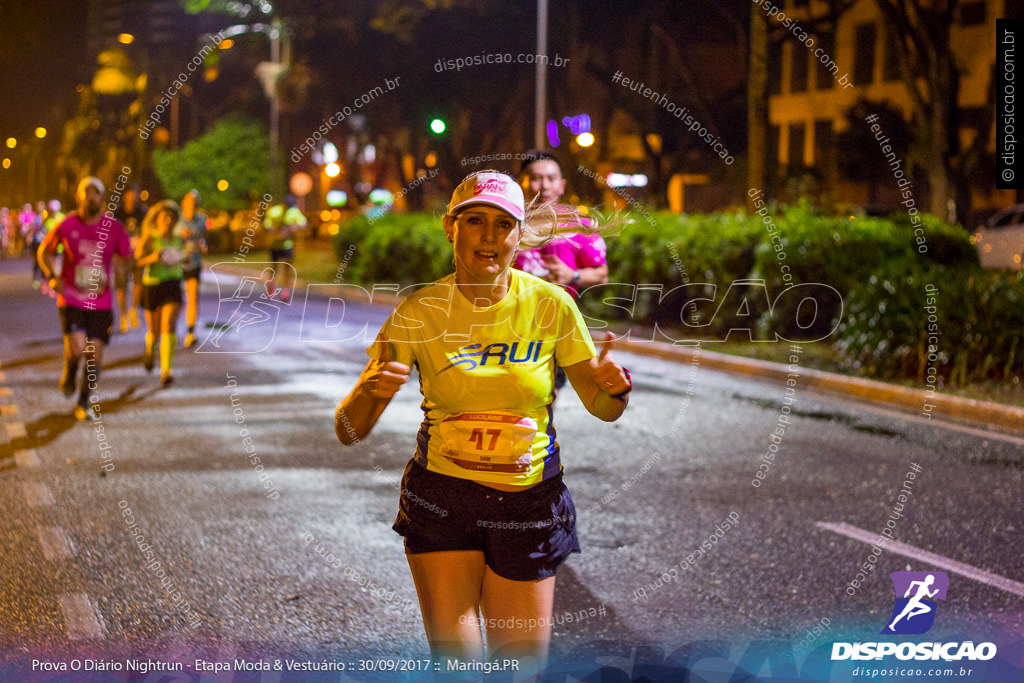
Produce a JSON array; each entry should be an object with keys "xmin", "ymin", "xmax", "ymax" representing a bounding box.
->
[{"xmin": 36, "ymin": 176, "xmax": 131, "ymax": 420}]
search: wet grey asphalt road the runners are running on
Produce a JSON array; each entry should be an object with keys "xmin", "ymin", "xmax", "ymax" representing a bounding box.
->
[{"xmin": 0, "ymin": 254, "xmax": 1024, "ymax": 680}]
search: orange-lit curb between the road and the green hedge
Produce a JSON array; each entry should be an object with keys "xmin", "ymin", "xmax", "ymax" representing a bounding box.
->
[{"xmin": 205, "ymin": 262, "xmax": 1024, "ymax": 434}]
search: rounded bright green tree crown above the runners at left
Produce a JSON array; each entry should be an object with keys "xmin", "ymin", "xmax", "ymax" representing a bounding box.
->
[{"xmin": 153, "ymin": 115, "xmax": 270, "ymax": 211}]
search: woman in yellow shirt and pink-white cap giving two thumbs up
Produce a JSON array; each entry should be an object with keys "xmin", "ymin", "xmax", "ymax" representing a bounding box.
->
[{"xmin": 335, "ymin": 171, "xmax": 632, "ymax": 670}]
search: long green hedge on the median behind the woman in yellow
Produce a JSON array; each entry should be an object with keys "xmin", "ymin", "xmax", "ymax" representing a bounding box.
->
[{"xmin": 335, "ymin": 204, "xmax": 1024, "ymax": 383}]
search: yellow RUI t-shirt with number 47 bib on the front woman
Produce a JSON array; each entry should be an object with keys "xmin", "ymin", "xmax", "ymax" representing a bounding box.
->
[{"xmin": 367, "ymin": 269, "xmax": 596, "ymax": 486}]
